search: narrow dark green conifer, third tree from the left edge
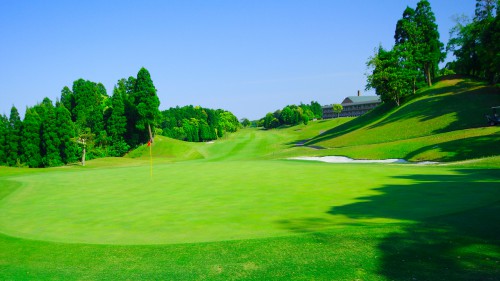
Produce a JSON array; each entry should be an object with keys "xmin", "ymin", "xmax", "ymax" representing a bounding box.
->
[{"xmin": 21, "ymin": 108, "xmax": 42, "ymax": 168}]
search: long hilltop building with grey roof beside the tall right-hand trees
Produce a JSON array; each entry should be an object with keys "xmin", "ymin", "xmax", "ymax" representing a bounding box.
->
[{"xmin": 323, "ymin": 91, "xmax": 382, "ymax": 119}]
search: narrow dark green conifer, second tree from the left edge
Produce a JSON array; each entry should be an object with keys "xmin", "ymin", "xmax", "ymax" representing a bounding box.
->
[{"xmin": 7, "ymin": 106, "xmax": 22, "ymax": 166}]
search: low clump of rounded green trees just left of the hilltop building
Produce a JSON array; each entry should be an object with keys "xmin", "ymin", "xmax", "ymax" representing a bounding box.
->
[{"xmin": 257, "ymin": 101, "xmax": 323, "ymax": 129}]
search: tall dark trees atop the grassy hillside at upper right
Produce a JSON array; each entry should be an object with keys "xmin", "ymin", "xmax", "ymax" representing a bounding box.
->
[{"xmin": 366, "ymin": 0, "xmax": 500, "ymax": 106}]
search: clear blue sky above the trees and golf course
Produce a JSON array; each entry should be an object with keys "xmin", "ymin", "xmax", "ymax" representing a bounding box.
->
[{"xmin": 0, "ymin": 0, "xmax": 475, "ymax": 119}]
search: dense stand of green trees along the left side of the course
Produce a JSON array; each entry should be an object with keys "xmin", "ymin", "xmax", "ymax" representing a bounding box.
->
[{"xmin": 0, "ymin": 68, "xmax": 240, "ymax": 167}]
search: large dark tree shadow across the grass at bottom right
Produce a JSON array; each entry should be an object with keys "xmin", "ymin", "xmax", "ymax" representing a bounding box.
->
[{"xmin": 328, "ymin": 169, "xmax": 500, "ymax": 280}]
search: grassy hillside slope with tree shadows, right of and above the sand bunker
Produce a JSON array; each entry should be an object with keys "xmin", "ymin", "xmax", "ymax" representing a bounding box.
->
[{"xmin": 306, "ymin": 79, "xmax": 500, "ymax": 161}]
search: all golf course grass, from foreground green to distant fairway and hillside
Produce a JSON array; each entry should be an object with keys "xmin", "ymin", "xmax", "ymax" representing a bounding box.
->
[{"xmin": 0, "ymin": 77, "xmax": 500, "ymax": 280}]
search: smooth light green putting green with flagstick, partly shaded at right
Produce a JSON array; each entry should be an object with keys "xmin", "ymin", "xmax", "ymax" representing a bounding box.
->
[{"xmin": 0, "ymin": 161, "xmax": 494, "ymax": 244}]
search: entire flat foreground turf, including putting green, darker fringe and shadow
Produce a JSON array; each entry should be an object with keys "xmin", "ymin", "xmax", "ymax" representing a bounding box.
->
[{"xmin": 0, "ymin": 160, "xmax": 500, "ymax": 280}]
